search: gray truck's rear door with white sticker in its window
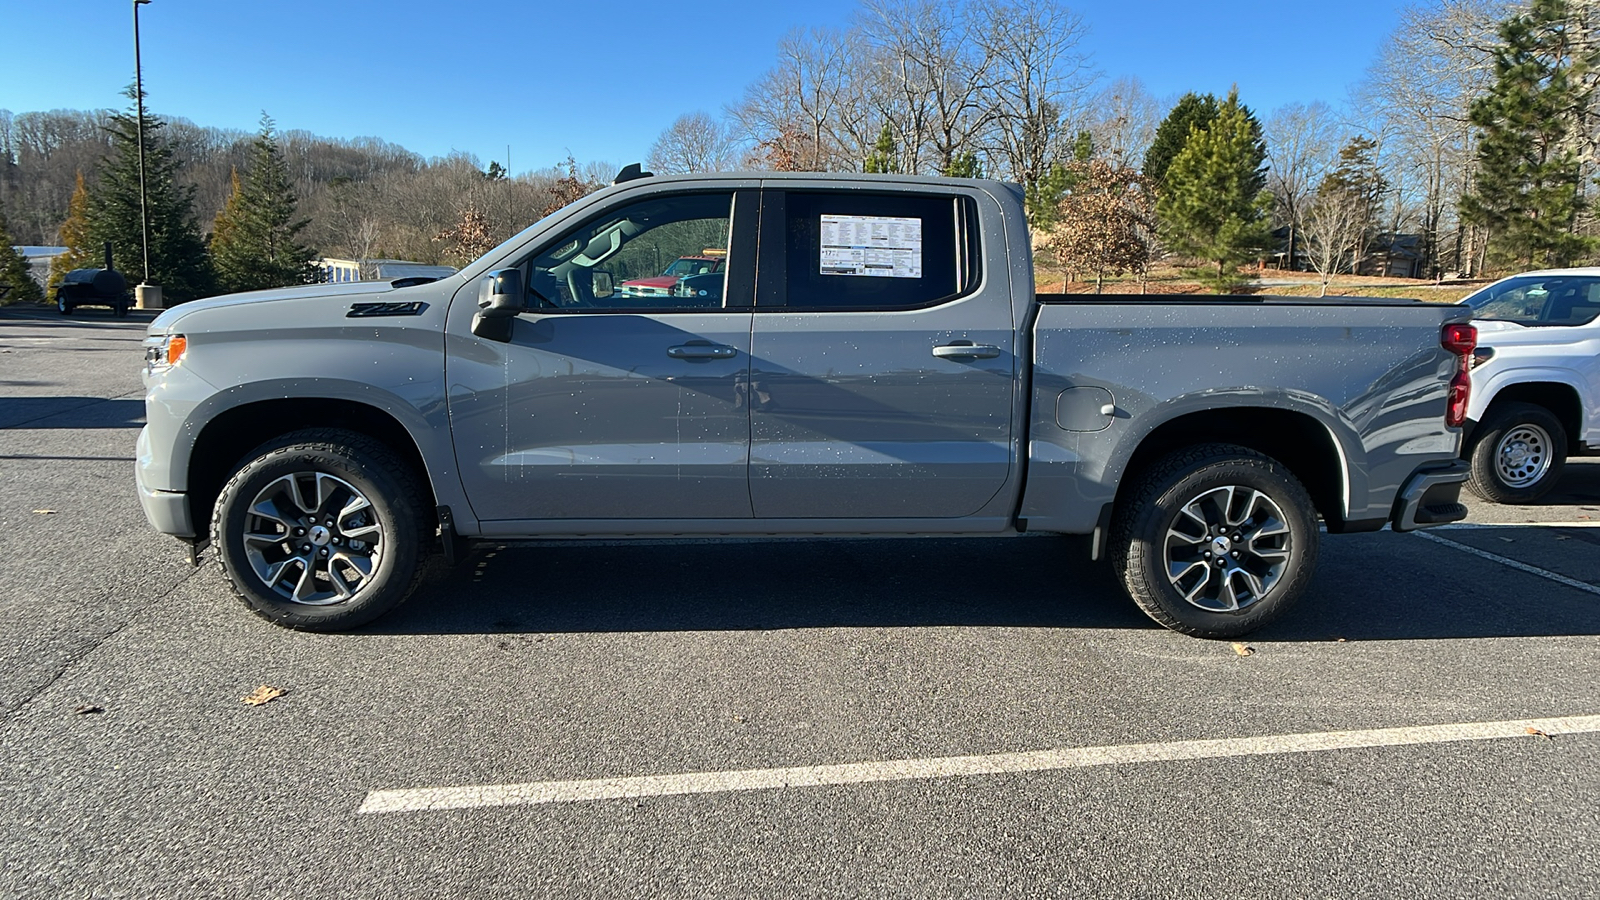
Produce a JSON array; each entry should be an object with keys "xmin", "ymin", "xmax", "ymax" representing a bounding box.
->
[{"xmin": 750, "ymin": 184, "xmax": 1018, "ymax": 519}]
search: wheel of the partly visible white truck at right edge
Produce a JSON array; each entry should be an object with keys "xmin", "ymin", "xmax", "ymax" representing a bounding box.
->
[{"xmin": 1466, "ymin": 404, "xmax": 1566, "ymax": 504}]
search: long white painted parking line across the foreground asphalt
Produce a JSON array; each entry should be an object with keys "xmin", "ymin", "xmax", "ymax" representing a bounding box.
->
[{"xmin": 357, "ymin": 716, "xmax": 1600, "ymax": 814}]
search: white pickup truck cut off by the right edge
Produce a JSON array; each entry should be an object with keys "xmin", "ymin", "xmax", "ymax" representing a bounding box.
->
[{"xmin": 1461, "ymin": 267, "xmax": 1600, "ymax": 503}]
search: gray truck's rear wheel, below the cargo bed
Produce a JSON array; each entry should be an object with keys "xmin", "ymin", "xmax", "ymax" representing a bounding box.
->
[{"xmin": 1110, "ymin": 444, "xmax": 1320, "ymax": 637}]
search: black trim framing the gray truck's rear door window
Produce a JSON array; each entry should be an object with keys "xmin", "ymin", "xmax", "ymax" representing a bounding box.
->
[{"xmin": 755, "ymin": 187, "xmax": 982, "ymax": 312}]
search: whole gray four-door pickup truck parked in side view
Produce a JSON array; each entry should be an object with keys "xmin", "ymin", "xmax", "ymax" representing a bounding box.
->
[{"xmin": 138, "ymin": 171, "xmax": 1474, "ymax": 637}]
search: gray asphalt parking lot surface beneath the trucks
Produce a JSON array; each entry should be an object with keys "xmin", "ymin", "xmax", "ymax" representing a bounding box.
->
[{"xmin": 0, "ymin": 304, "xmax": 1600, "ymax": 898}]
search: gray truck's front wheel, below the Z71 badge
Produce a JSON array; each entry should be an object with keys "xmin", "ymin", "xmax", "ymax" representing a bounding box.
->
[{"xmin": 211, "ymin": 429, "xmax": 434, "ymax": 631}]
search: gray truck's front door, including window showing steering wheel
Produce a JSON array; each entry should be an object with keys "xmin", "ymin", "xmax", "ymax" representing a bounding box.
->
[{"xmin": 446, "ymin": 191, "xmax": 755, "ymax": 522}]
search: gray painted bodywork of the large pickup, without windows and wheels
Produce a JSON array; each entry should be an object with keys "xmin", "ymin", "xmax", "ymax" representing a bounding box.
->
[{"xmin": 138, "ymin": 175, "xmax": 1467, "ymax": 538}]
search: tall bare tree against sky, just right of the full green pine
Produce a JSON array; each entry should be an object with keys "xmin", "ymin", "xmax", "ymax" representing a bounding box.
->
[{"xmin": 1264, "ymin": 101, "xmax": 1344, "ymax": 269}]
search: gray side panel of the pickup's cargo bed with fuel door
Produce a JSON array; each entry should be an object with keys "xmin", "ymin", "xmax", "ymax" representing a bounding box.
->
[{"xmin": 1022, "ymin": 295, "xmax": 1470, "ymax": 533}]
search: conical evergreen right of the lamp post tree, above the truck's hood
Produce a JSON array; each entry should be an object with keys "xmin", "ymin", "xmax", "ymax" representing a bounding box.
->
[{"xmin": 211, "ymin": 115, "xmax": 317, "ymax": 291}]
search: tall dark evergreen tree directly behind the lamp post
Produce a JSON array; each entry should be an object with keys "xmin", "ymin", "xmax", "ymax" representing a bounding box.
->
[{"xmin": 88, "ymin": 88, "xmax": 213, "ymax": 303}]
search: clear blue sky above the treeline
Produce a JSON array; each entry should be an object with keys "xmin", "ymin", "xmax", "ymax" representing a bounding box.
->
[{"xmin": 0, "ymin": 0, "xmax": 1400, "ymax": 171}]
